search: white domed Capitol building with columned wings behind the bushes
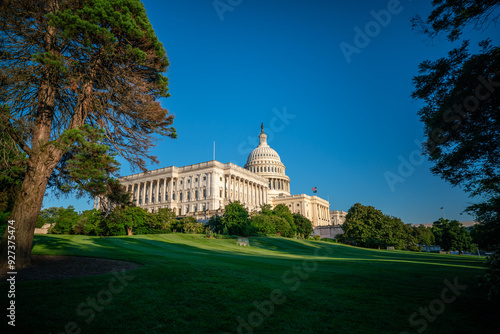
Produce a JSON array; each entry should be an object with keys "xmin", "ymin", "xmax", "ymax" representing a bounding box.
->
[{"xmin": 96, "ymin": 125, "xmax": 331, "ymax": 227}]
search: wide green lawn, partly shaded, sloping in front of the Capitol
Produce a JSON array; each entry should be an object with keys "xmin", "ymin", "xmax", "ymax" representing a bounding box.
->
[{"xmin": 0, "ymin": 234, "xmax": 499, "ymax": 334}]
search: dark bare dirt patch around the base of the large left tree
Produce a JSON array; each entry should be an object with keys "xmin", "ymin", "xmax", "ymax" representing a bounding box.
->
[{"xmin": 0, "ymin": 255, "xmax": 142, "ymax": 283}]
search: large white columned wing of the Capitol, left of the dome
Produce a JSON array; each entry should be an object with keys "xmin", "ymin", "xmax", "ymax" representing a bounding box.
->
[{"xmin": 100, "ymin": 160, "xmax": 268, "ymax": 216}]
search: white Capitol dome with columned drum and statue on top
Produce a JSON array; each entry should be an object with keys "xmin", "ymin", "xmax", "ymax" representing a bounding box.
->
[{"xmin": 245, "ymin": 125, "xmax": 290, "ymax": 196}]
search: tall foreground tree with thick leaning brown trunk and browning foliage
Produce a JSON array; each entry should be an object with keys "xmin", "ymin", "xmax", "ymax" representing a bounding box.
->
[{"xmin": 0, "ymin": 0, "xmax": 176, "ymax": 267}]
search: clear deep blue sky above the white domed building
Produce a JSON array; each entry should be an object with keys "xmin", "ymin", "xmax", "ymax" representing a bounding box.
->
[{"xmin": 44, "ymin": 0, "xmax": 496, "ymax": 223}]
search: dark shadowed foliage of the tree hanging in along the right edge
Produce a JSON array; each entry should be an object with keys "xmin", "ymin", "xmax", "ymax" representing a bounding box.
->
[{"xmin": 412, "ymin": 0, "xmax": 500, "ymax": 247}]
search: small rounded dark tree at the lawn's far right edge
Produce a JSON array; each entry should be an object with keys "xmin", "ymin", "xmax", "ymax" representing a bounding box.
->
[{"xmin": 432, "ymin": 218, "xmax": 472, "ymax": 254}]
